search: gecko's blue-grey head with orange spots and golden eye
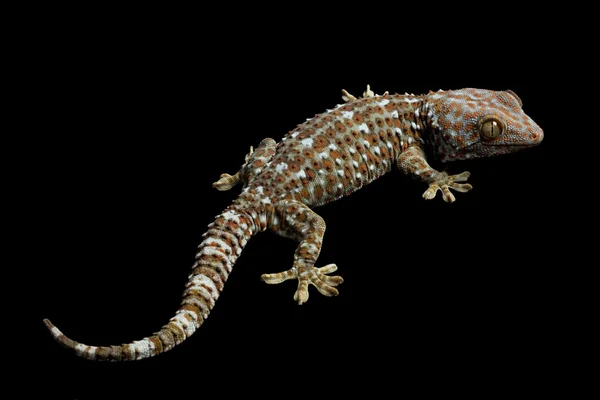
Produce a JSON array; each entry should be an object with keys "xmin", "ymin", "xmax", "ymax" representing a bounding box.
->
[{"xmin": 428, "ymin": 89, "xmax": 544, "ymax": 162}]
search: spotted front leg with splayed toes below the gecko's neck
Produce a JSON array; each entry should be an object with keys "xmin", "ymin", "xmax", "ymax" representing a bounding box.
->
[{"xmin": 397, "ymin": 146, "xmax": 473, "ymax": 203}]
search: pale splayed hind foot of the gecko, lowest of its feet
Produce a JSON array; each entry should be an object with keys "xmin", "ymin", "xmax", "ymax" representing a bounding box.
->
[{"xmin": 261, "ymin": 264, "xmax": 344, "ymax": 304}]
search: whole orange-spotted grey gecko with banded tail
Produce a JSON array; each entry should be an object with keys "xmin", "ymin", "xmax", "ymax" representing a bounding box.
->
[{"xmin": 43, "ymin": 86, "xmax": 544, "ymax": 361}]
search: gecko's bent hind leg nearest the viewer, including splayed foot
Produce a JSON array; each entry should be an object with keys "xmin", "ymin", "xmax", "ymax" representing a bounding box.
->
[{"xmin": 261, "ymin": 200, "xmax": 344, "ymax": 304}]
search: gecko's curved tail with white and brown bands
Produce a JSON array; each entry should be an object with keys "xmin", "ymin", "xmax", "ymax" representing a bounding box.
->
[{"xmin": 44, "ymin": 201, "xmax": 264, "ymax": 361}]
